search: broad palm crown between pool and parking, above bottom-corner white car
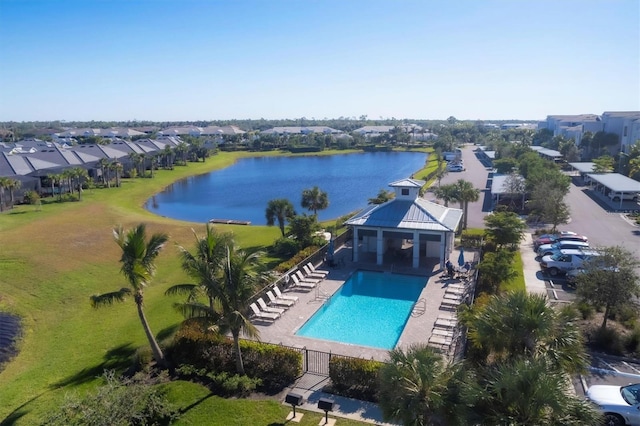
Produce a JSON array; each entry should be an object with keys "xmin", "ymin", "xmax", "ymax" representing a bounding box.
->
[{"xmin": 461, "ymin": 291, "xmax": 587, "ymax": 373}]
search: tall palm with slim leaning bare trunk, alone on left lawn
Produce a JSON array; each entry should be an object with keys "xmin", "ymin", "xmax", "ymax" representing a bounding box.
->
[{"xmin": 91, "ymin": 223, "xmax": 169, "ymax": 366}]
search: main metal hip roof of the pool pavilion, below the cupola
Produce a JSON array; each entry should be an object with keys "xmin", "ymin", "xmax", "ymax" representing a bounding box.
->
[{"xmin": 345, "ymin": 198, "xmax": 462, "ymax": 232}]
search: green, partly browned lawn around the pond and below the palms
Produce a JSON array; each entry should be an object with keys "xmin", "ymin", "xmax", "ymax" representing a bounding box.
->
[{"xmin": 0, "ymin": 151, "xmax": 400, "ymax": 425}]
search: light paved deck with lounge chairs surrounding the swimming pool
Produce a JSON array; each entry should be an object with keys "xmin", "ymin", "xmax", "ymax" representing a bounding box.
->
[{"xmin": 254, "ymin": 247, "xmax": 473, "ymax": 361}]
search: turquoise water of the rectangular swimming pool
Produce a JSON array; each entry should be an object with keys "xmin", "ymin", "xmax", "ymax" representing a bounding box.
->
[{"xmin": 296, "ymin": 271, "xmax": 427, "ymax": 349}]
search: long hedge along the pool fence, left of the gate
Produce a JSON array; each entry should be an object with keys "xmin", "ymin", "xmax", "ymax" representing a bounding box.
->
[{"xmin": 168, "ymin": 322, "xmax": 302, "ymax": 392}]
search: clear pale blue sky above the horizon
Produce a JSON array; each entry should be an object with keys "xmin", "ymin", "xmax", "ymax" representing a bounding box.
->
[{"xmin": 0, "ymin": 0, "xmax": 640, "ymax": 121}]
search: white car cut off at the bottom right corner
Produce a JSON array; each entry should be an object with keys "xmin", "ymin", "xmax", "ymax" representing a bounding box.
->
[{"xmin": 587, "ymin": 383, "xmax": 640, "ymax": 426}]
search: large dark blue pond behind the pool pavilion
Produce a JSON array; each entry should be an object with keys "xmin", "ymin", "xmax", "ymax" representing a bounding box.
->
[{"xmin": 145, "ymin": 152, "xmax": 427, "ymax": 225}]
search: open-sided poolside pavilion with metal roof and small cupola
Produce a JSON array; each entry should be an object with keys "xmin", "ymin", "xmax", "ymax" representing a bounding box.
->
[{"xmin": 345, "ymin": 179, "xmax": 463, "ymax": 268}]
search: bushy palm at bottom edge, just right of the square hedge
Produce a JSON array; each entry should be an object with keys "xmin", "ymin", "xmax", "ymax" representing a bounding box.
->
[{"xmin": 380, "ymin": 344, "xmax": 452, "ymax": 426}]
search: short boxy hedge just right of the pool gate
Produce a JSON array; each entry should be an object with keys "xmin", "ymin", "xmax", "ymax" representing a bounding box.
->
[{"xmin": 329, "ymin": 357, "xmax": 383, "ymax": 402}]
